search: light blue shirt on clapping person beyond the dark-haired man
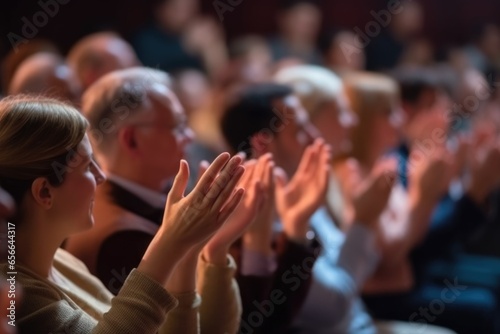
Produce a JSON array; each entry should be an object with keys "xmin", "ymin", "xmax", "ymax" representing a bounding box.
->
[{"xmin": 293, "ymin": 208, "xmax": 380, "ymax": 334}]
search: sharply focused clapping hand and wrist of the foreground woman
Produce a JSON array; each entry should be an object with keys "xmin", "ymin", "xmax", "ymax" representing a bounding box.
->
[{"xmin": 137, "ymin": 153, "xmax": 245, "ymax": 284}]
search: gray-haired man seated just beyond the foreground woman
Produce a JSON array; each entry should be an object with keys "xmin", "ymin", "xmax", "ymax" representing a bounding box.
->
[{"xmin": 66, "ymin": 68, "xmax": 241, "ymax": 334}]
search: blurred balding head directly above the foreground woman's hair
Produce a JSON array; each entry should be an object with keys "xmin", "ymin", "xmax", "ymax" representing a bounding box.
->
[{"xmin": 8, "ymin": 52, "xmax": 81, "ymax": 105}]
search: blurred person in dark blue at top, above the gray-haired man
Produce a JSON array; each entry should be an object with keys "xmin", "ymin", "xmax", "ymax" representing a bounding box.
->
[{"xmin": 132, "ymin": 0, "xmax": 227, "ymax": 78}]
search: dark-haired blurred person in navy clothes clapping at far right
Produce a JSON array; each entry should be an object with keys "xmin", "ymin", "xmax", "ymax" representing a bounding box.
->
[{"xmin": 364, "ymin": 68, "xmax": 500, "ymax": 333}]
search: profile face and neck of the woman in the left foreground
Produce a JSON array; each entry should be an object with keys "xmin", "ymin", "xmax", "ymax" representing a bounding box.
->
[{"xmin": 51, "ymin": 135, "xmax": 105, "ymax": 235}]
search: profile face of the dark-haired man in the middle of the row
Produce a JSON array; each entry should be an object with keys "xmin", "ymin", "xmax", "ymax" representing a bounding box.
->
[{"xmin": 269, "ymin": 95, "xmax": 319, "ymax": 177}]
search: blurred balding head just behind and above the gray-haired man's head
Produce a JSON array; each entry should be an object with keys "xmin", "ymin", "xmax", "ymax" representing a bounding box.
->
[{"xmin": 67, "ymin": 32, "xmax": 140, "ymax": 91}]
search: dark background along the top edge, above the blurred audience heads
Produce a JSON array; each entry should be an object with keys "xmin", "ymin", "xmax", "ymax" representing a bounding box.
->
[{"xmin": 0, "ymin": 0, "xmax": 500, "ymax": 55}]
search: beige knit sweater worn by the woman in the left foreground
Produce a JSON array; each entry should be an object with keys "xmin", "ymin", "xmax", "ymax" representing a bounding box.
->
[{"xmin": 0, "ymin": 249, "xmax": 241, "ymax": 334}]
